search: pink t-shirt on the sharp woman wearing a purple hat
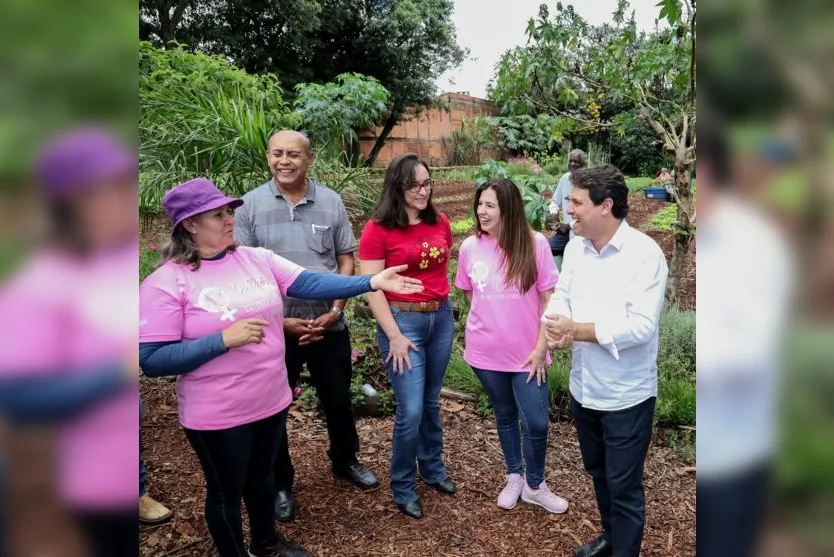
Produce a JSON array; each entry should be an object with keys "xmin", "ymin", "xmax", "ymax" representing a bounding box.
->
[{"xmin": 139, "ymin": 247, "xmax": 303, "ymax": 430}]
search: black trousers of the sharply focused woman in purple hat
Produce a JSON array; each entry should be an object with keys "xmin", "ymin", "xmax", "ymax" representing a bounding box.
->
[{"xmin": 184, "ymin": 410, "xmax": 287, "ymax": 557}]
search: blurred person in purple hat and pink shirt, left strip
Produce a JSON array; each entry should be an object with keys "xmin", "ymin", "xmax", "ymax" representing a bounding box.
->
[{"xmin": 0, "ymin": 127, "xmax": 140, "ymax": 557}]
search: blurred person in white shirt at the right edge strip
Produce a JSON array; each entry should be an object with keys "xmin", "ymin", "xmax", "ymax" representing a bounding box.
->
[{"xmin": 696, "ymin": 116, "xmax": 794, "ymax": 557}]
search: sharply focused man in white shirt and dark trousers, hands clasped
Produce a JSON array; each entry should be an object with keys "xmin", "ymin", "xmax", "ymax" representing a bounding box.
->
[{"xmin": 542, "ymin": 165, "xmax": 668, "ymax": 557}]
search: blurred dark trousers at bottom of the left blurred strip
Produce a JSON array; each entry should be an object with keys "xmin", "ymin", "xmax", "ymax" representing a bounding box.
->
[{"xmin": 75, "ymin": 509, "xmax": 139, "ymax": 557}]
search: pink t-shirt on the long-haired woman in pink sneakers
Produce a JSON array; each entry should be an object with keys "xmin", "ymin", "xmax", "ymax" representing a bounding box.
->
[{"xmin": 455, "ymin": 232, "xmax": 559, "ymax": 372}]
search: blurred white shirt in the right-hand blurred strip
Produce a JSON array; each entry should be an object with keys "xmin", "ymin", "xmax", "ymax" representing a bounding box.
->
[{"xmin": 696, "ymin": 196, "xmax": 795, "ymax": 478}]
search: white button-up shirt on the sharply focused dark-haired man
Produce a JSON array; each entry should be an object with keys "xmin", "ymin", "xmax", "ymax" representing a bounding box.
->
[{"xmin": 545, "ymin": 221, "xmax": 669, "ymax": 411}]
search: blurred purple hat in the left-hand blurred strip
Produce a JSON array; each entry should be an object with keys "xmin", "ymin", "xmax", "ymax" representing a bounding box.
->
[{"xmin": 35, "ymin": 127, "xmax": 139, "ymax": 199}]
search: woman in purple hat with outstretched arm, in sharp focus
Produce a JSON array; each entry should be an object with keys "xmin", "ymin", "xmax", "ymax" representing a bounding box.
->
[{"xmin": 139, "ymin": 178, "xmax": 422, "ymax": 557}]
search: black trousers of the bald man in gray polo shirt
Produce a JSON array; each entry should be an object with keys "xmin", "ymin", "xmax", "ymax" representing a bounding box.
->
[{"xmin": 275, "ymin": 327, "xmax": 359, "ymax": 493}]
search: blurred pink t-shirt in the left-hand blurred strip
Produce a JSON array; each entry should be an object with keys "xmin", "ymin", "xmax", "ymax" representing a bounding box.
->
[{"xmin": 0, "ymin": 243, "xmax": 139, "ymax": 512}]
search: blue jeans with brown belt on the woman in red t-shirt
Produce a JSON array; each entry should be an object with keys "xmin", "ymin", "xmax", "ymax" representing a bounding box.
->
[{"xmin": 377, "ymin": 303, "xmax": 455, "ymax": 505}]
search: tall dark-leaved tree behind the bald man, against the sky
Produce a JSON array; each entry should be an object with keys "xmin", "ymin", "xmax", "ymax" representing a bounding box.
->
[{"xmin": 140, "ymin": 0, "xmax": 466, "ymax": 164}]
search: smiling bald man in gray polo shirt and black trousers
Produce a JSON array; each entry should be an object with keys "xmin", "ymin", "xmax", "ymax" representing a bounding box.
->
[{"xmin": 235, "ymin": 130, "xmax": 379, "ymax": 520}]
